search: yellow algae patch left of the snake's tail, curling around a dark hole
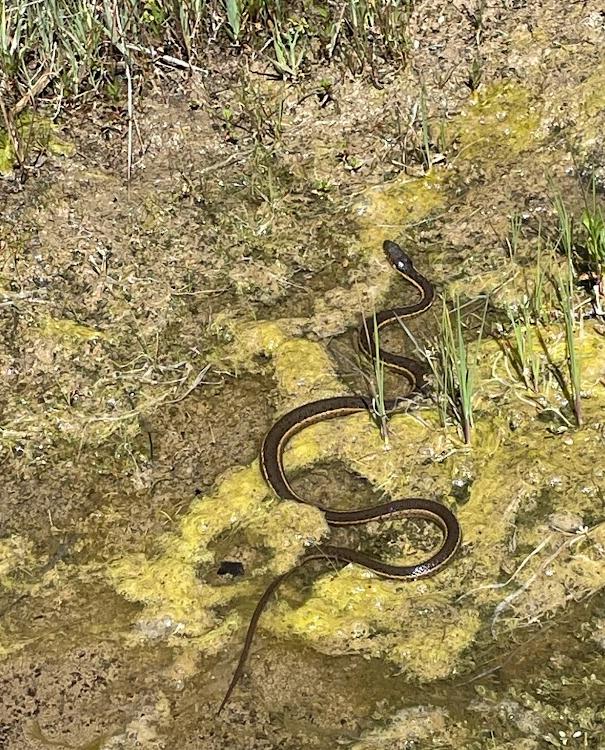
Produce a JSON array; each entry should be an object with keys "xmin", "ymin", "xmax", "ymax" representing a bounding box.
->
[{"xmin": 109, "ymin": 462, "xmax": 325, "ymax": 651}]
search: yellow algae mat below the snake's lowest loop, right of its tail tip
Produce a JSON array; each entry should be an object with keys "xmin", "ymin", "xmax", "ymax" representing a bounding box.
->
[{"xmin": 267, "ymin": 565, "xmax": 480, "ymax": 681}]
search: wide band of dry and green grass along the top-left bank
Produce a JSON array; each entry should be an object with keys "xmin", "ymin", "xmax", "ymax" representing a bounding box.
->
[{"xmin": 0, "ymin": 0, "xmax": 412, "ymax": 167}]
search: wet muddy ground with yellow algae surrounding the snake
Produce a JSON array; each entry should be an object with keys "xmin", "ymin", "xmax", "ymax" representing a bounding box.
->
[{"xmin": 0, "ymin": 1, "xmax": 605, "ymax": 750}]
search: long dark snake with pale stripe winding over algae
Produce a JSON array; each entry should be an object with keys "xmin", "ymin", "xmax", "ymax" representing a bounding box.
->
[{"xmin": 217, "ymin": 240, "xmax": 462, "ymax": 713}]
